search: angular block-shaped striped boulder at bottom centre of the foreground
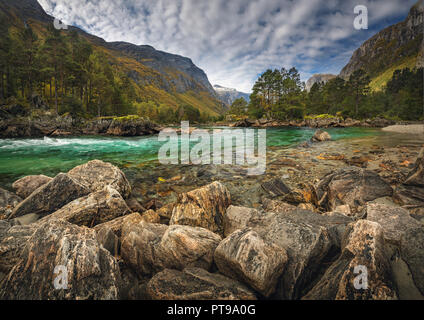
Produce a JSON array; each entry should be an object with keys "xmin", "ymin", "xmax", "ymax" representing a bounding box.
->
[{"xmin": 215, "ymin": 228, "xmax": 288, "ymax": 297}]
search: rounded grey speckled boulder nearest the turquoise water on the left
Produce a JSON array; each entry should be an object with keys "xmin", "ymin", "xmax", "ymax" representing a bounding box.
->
[{"xmin": 68, "ymin": 160, "xmax": 131, "ymax": 199}]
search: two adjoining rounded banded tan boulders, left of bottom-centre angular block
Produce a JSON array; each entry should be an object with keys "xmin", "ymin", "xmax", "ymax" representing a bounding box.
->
[{"xmin": 121, "ymin": 221, "xmax": 221, "ymax": 275}]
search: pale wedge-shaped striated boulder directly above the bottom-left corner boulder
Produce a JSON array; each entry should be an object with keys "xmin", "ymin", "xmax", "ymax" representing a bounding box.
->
[{"xmin": 38, "ymin": 186, "xmax": 131, "ymax": 228}]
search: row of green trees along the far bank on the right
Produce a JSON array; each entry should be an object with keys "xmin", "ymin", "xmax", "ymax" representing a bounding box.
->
[{"xmin": 229, "ymin": 68, "xmax": 424, "ymax": 120}]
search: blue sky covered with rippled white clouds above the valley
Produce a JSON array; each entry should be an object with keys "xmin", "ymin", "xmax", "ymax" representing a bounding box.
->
[{"xmin": 38, "ymin": 0, "xmax": 416, "ymax": 93}]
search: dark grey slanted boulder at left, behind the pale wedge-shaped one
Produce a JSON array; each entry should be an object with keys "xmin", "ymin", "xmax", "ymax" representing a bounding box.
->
[{"xmin": 9, "ymin": 173, "xmax": 89, "ymax": 218}]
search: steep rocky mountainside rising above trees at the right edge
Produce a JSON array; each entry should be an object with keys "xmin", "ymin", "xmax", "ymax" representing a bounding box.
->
[{"xmin": 340, "ymin": 0, "xmax": 424, "ymax": 89}]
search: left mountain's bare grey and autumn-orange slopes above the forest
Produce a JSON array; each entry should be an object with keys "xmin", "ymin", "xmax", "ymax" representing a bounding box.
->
[{"xmin": 0, "ymin": 0, "xmax": 224, "ymax": 115}]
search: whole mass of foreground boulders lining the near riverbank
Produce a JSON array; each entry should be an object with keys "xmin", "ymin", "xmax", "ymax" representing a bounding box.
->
[{"xmin": 0, "ymin": 131, "xmax": 424, "ymax": 300}]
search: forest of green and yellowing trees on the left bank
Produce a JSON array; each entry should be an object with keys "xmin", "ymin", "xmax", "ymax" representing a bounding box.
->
[{"xmin": 0, "ymin": 19, "xmax": 212, "ymax": 123}]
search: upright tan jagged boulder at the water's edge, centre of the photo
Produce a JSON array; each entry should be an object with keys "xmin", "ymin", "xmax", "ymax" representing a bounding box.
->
[{"xmin": 169, "ymin": 181, "xmax": 231, "ymax": 233}]
